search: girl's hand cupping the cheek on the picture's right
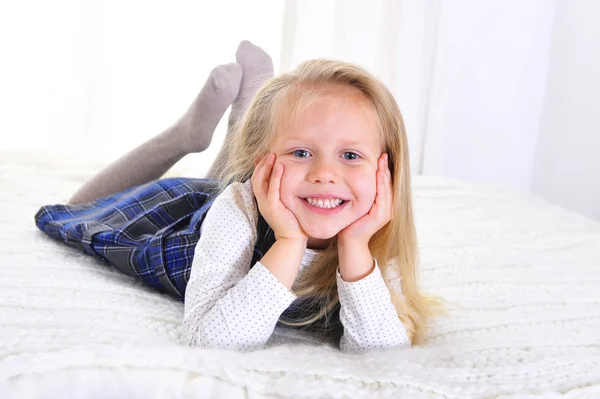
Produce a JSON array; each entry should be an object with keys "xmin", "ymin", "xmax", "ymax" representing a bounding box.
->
[{"xmin": 338, "ymin": 153, "xmax": 394, "ymax": 245}]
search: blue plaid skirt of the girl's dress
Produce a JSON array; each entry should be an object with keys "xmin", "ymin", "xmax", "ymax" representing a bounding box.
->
[{"xmin": 35, "ymin": 178, "xmax": 216, "ymax": 300}]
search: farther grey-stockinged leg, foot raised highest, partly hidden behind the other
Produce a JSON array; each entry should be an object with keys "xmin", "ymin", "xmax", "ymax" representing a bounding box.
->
[{"xmin": 207, "ymin": 40, "xmax": 273, "ymax": 178}]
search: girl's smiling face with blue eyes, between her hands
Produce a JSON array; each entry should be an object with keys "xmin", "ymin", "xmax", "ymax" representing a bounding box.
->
[{"xmin": 269, "ymin": 89, "xmax": 382, "ymax": 248}]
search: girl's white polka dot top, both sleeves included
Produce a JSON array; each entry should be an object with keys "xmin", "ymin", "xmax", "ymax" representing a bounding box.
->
[{"xmin": 182, "ymin": 181, "xmax": 410, "ymax": 352}]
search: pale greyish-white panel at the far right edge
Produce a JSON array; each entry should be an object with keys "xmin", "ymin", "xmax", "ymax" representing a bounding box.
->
[{"xmin": 532, "ymin": 0, "xmax": 600, "ymax": 221}]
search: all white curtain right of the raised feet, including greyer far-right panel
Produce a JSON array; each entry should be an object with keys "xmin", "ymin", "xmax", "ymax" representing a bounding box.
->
[{"xmin": 281, "ymin": 0, "xmax": 600, "ymax": 220}]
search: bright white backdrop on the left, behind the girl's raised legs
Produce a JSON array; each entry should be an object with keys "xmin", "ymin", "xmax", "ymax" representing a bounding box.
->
[{"xmin": 0, "ymin": 0, "xmax": 284, "ymax": 173}]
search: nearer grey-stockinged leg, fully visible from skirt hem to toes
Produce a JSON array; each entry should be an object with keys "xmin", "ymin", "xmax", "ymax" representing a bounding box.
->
[{"xmin": 69, "ymin": 63, "xmax": 243, "ymax": 204}]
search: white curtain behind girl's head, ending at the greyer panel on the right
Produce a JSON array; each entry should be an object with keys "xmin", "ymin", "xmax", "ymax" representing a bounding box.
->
[{"xmin": 281, "ymin": 0, "xmax": 553, "ymax": 188}]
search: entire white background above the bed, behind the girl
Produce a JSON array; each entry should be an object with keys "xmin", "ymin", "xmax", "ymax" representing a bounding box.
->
[{"xmin": 0, "ymin": 0, "xmax": 600, "ymax": 220}]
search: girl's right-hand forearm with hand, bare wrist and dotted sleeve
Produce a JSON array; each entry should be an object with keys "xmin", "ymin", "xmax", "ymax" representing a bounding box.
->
[{"xmin": 337, "ymin": 154, "xmax": 411, "ymax": 352}]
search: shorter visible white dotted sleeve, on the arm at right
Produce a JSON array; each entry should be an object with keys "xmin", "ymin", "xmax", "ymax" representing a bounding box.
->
[{"xmin": 337, "ymin": 261, "xmax": 411, "ymax": 353}]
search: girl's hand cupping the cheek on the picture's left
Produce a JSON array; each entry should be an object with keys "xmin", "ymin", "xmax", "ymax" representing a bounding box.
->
[{"xmin": 250, "ymin": 153, "xmax": 308, "ymax": 241}]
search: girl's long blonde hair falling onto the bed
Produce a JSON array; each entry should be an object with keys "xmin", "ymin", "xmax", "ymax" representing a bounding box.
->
[{"xmin": 216, "ymin": 60, "xmax": 447, "ymax": 345}]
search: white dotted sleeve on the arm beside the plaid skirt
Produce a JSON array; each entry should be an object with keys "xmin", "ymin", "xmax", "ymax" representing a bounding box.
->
[{"xmin": 182, "ymin": 183, "xmax": 296, "ymax": 351}]
